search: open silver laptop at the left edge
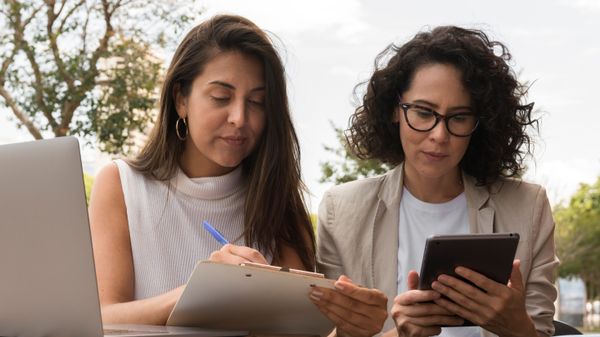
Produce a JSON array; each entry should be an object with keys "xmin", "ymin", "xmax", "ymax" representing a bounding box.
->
[{"xmin": 0, "ymin": 137, "xmax": 246, "ymax": 337}]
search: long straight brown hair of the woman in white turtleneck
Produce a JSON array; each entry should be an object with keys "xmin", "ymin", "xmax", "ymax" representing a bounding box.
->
[{"xmin": 130, "ymin": 15, "xmax": 315, "ymax": 269}]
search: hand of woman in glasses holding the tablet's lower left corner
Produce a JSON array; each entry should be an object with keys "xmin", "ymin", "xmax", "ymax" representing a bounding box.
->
[{"xmin": 391, "ymin": 270, "xmax": 463, "ymax": 337}]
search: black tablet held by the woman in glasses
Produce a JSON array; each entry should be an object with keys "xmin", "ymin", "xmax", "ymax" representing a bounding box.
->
[{"xmin": 419, "ymin": 233, "xmax": 519, "ymax": 325}]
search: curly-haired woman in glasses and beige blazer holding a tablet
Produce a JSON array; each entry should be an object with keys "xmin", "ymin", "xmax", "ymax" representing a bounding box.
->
[{"xmin": 316, "ymin": 26, "xmax": 558, "ymax": 336}]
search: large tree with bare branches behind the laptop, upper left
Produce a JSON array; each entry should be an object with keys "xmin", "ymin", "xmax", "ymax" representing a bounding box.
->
[{"xmin": 0, "ymin": 0, "xmax": 199, "ymax": 153}]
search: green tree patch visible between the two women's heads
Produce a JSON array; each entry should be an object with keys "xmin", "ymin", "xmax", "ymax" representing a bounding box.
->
[{"xmin": 319, "ymin": 123, "xmax": 392, "ymax": 184}]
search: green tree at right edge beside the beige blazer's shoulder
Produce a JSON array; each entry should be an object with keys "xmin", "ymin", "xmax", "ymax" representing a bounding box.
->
[{"xmin": 553, "ymin": 177, "xmax": 600, "ymax": 298}]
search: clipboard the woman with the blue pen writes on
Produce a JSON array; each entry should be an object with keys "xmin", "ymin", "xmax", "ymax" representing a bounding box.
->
[{"xmin": 167, "ymin": 261, "xmax": 335, "ymax": 335}]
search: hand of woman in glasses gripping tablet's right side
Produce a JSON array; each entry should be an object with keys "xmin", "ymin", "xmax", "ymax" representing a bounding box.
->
[{"xmin": 432, "ymin": 260, "xmax": 537, "ymax": 336}]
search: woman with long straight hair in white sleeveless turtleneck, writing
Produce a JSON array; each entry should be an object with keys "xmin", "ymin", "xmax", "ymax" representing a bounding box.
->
[{"xmin": 89, "ymin": 15, "xmax": 386, "ymax": 332}]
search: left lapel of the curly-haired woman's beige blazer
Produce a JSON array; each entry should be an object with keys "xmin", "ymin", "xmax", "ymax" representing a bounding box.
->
[{"xmin": 371, "ymin": 165, "xmax": 403, "ymax": 307}]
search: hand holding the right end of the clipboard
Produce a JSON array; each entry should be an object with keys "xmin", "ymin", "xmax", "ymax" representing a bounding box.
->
[{"xmin": 310, "ymin": 275, "xmax": 387, "ymax": 337}]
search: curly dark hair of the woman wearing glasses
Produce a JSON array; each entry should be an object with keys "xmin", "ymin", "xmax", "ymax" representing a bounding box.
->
[{"xmin": 346, "ymin": 26, "xmax": 537, "ymax": 185}]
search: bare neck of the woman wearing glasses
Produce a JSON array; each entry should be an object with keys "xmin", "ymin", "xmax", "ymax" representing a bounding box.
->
[{"xmin": 404, "ymin": 165, "xmax": 465, "ymax": 203}]
